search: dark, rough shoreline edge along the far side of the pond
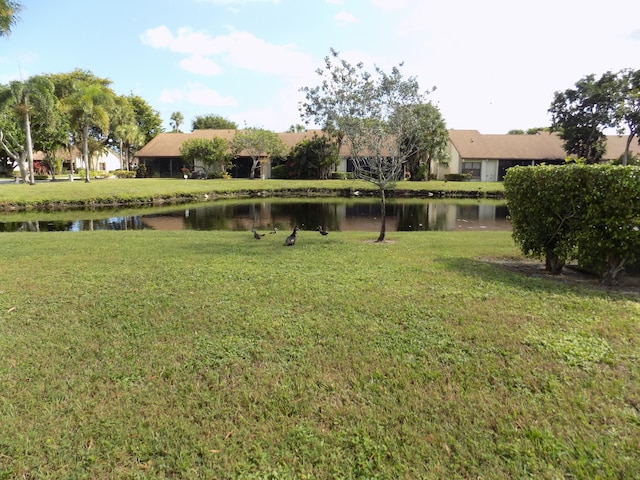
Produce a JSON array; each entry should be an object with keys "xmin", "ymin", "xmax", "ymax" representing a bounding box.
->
[{"xmin": 0, "ymin": 188, "xmax": 505, "ymax": 213}]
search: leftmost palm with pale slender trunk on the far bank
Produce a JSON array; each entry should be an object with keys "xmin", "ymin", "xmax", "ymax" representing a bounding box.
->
[{"xmin": 0, "ymin": 76, "xmax": 56, "ymax": 184}]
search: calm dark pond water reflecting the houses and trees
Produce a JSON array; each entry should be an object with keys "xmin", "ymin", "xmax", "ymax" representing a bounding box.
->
[{"xmin": 0, "ymin": 198, "xmax": 511, "ymax": 232}]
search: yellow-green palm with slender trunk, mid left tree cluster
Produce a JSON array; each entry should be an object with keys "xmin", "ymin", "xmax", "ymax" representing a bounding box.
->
[{"xmin": 63, "ymin": 81, "xmax": 115, "ymax": 183}]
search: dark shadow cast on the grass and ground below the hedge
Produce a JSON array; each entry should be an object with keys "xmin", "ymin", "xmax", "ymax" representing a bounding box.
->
[{"xmin": 435, "ymin": 257, "xmax": 640, "ymax": 302}]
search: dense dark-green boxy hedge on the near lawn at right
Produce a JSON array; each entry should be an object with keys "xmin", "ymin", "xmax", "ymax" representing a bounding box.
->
[{"xmin": 504, "ymin": 165, "xmax": 640, "ymax": 282}]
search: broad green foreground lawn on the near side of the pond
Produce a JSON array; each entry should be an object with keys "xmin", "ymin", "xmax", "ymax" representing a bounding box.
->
[{"xmin": 0, "ymin": 231, "xmax": 640, "ymax": 479}]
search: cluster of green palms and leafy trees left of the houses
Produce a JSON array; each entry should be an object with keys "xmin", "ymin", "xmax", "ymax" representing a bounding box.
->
[{"xmin": 0, "ymin": 70, "xmax": 162, "ymax": 184}]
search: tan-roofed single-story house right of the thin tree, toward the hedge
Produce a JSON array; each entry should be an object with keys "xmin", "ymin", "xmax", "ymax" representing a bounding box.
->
[{"xmin": 431, "ymin": 130, "xmax": 640, "ymax": 182}]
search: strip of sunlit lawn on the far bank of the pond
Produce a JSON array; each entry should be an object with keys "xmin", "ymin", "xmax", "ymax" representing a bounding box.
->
[{"xmin": 0, "ymin": 178, "xmax": 504, "ymax": 209}]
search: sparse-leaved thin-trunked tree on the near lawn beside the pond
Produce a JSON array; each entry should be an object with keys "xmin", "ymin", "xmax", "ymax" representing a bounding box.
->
[{"xmin": 301, "ymin": 49, "xmax": 436, "ymax": 242}]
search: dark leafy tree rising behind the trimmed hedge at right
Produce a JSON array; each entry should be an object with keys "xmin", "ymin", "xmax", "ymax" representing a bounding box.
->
[{"xmin": 549, "ymin": 72, "xmax": 620, "ymax": 163}]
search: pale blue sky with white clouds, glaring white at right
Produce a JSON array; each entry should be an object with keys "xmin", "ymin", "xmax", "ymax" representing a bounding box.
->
[{"xmin": 0, "ymin": 0, "xmax": 640, "ymax": 134}]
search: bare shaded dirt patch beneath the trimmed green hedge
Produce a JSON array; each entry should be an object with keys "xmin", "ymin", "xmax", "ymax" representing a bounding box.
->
[{"xmin": 479, "ymin": 257, "xmax": 640, "ymax": 295}]
